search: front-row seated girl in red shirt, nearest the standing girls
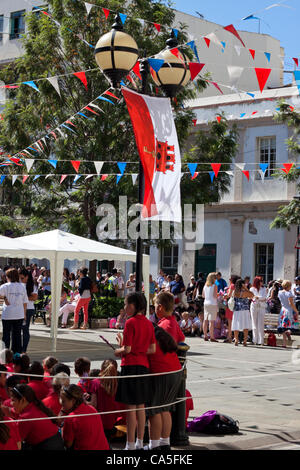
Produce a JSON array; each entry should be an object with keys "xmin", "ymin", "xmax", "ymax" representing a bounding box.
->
[{"xmin": 60, "ymin": 384, "xmax": 109, "ymax": 450}]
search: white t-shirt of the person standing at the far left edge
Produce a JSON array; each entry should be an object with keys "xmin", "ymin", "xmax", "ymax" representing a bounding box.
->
[{"xmin": 0, "ymin": 282, "xmax": 28, "ymax": 320}]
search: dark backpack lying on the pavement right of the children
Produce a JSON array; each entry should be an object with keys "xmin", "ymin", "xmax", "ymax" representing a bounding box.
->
[{"xmin": 187, "ymin": 410, "xmax": 239, "ymax": 435}]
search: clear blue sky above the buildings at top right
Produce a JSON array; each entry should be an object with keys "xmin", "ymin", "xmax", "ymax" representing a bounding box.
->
[{"xmin": 173, "ymin": 0, "xmax": 300, "ymax": 70}]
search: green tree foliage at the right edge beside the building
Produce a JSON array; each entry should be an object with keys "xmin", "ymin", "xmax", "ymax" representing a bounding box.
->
[{"xmin": 271, "ymin": 102, "xmax": 300, "ymax": 229}]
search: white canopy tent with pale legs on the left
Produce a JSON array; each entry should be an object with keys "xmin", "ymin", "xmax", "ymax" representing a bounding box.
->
[{"xmin": 14, "ymin": 230, "xmax": 149, "ymax": 352}]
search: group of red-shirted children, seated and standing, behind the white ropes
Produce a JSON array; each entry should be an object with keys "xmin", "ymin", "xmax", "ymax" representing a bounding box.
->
[{"xmin": 0, "ymin": 292, "xmax": 192, "ymax": 451}]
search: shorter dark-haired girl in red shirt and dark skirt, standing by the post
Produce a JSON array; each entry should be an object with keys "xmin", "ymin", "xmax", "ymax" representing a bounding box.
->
[{"xmin": 147, "ymin": 326, "xmax": 182, "ymax": 450}]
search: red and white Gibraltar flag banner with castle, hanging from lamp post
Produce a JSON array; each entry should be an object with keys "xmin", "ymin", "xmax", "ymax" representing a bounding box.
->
[{"xmin": 122, "ymin": 87, "xmax": 182, "ymax": 223}]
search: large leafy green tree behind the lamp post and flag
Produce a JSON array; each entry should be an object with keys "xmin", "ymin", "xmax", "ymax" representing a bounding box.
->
[{"xmin": 0, "ymin": 0, "xmax": 238, "ymax": 239}]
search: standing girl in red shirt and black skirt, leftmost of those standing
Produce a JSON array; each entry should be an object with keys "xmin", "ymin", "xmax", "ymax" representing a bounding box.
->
[{"xmin": 115, "ymin": 292, "xmax": 155, "ymax": 450}]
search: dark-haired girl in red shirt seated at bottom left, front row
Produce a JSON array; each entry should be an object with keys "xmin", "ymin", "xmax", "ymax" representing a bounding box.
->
[{"xmin": 11, "ymin": 384, "xmax": 64, "ymax": 450}]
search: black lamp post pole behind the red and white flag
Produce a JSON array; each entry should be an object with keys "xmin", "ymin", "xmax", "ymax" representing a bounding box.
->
[{"xmin": 135, "ymin": 59, "xmax": 150, "ymax": 294}]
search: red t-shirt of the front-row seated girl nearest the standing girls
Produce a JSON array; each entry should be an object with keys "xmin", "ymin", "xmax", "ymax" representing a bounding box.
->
[{"xmin": 63, "ymin": 403, "xmax": 109, "ymax": 450}]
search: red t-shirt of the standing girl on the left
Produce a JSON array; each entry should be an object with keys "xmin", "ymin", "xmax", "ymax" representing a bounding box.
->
[{"xmin": 121, "ymin": 314, "xmax": 155, "ymax": 367}]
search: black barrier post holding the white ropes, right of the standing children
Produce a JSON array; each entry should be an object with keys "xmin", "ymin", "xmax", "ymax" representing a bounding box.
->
[{"xmin": 170, "ymin": 343, "xmax": 190, "ymax": 446}]
